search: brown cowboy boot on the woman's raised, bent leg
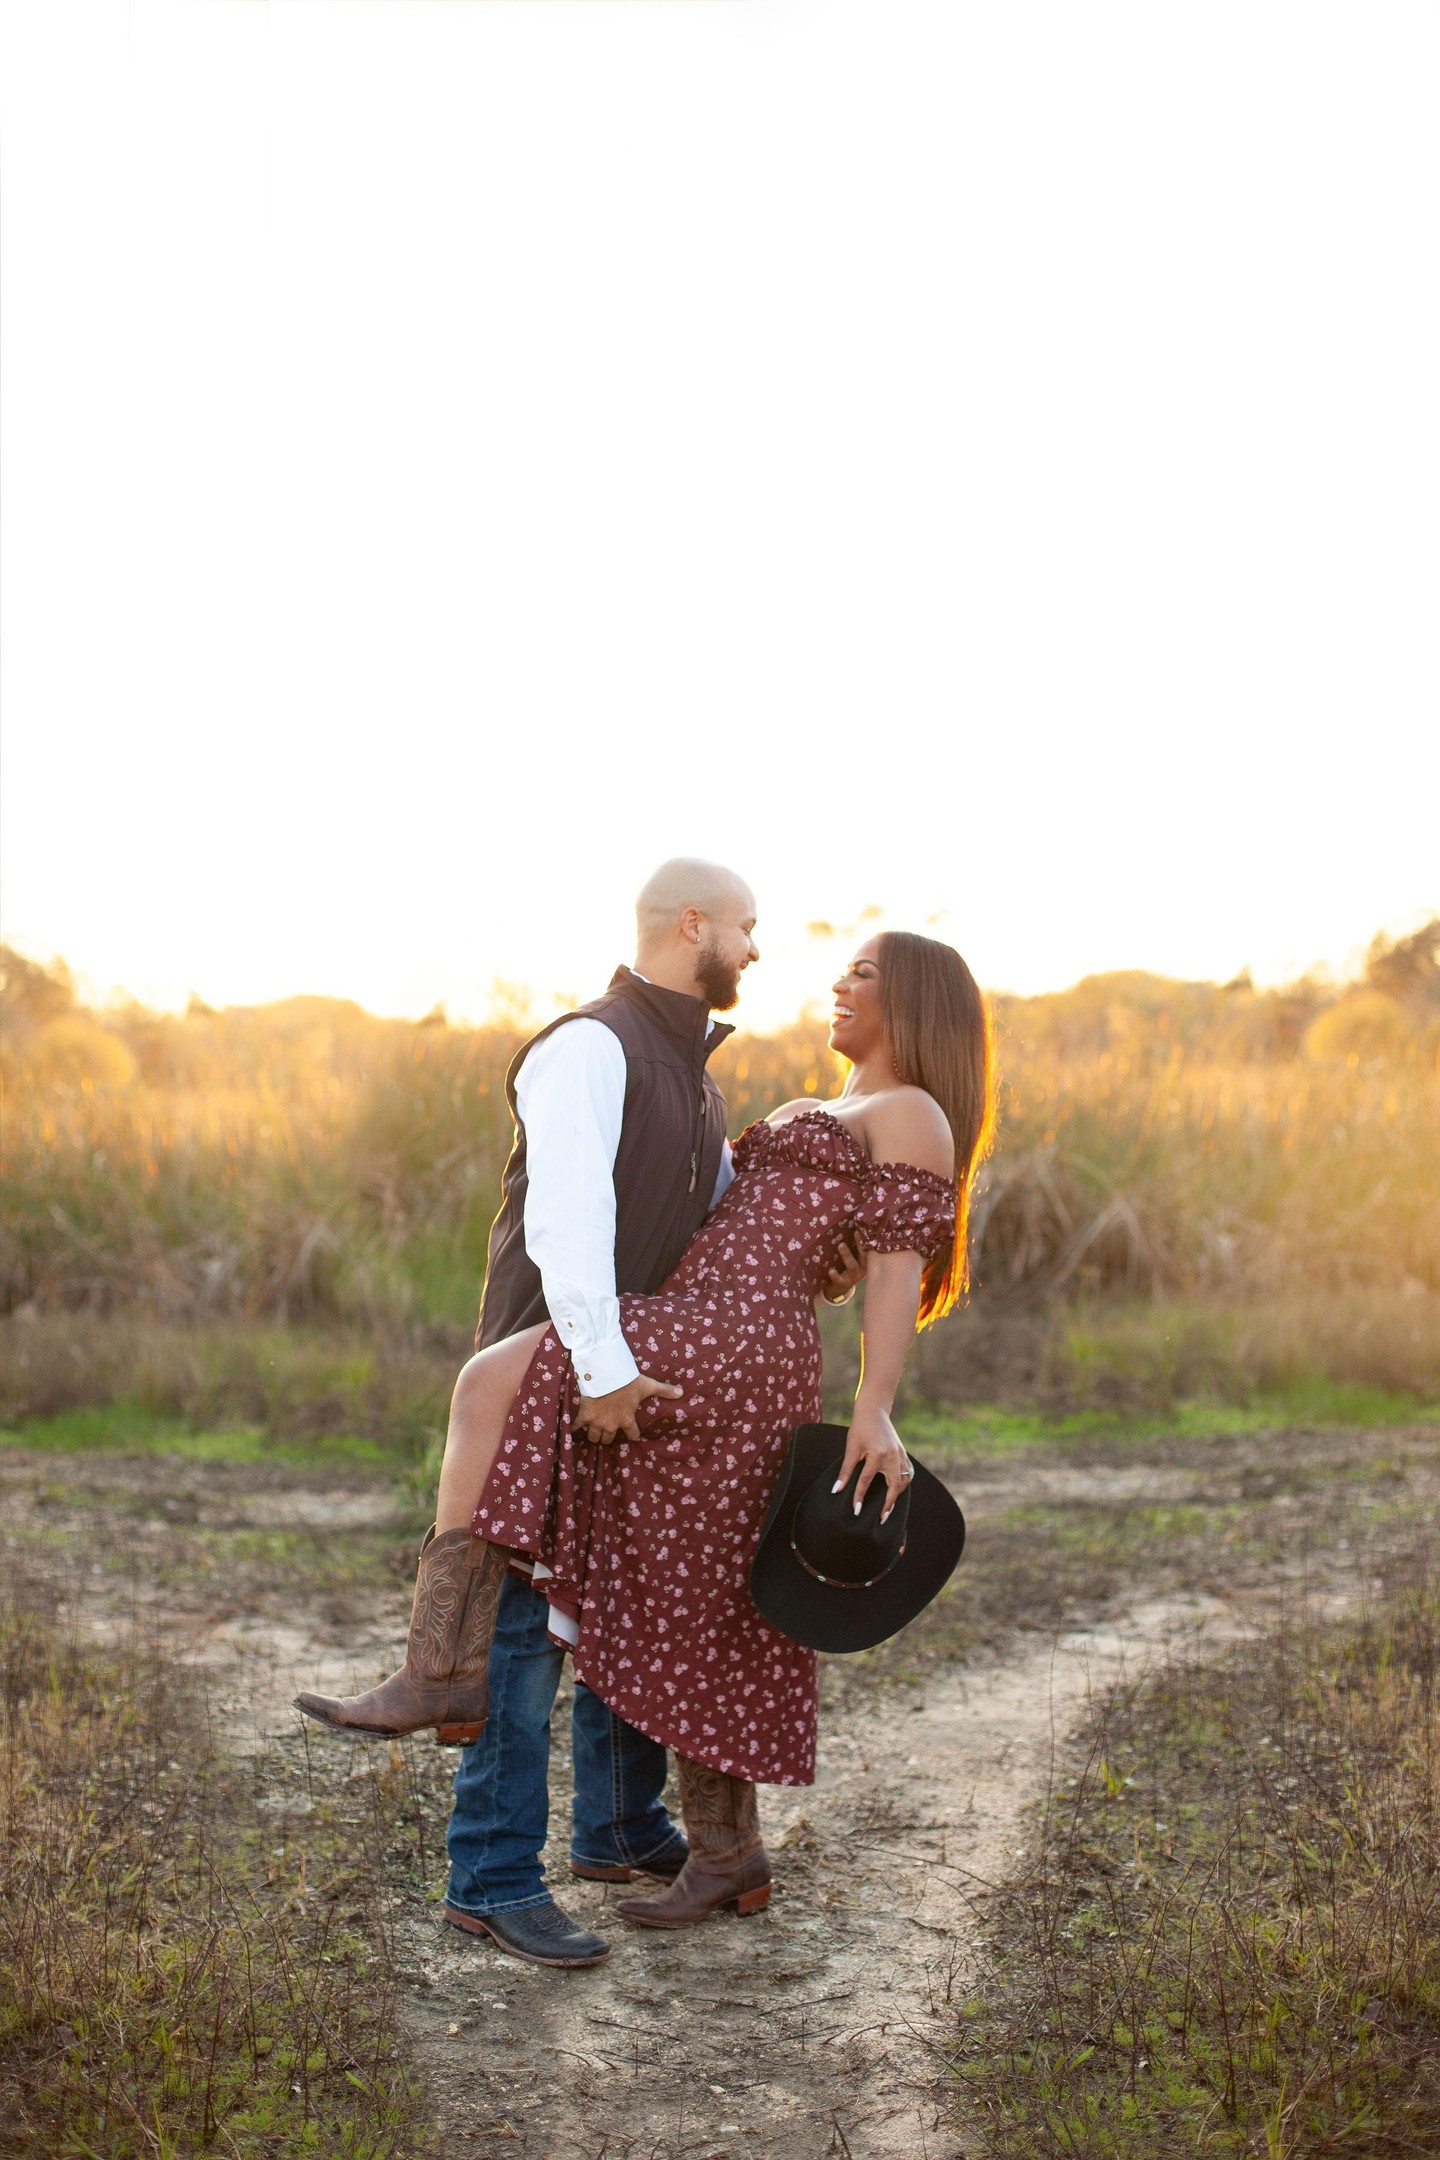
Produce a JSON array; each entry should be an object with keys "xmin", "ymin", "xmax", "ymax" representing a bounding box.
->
[{"xmin": 296, "ymin": 1529, "xmax": 505, "ymax": 1747}]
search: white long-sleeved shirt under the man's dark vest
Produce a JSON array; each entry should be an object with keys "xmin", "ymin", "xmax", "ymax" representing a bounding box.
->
[{"xmin": 516, "ymin": 1020, "xmax": 734, "ymax": 1395}]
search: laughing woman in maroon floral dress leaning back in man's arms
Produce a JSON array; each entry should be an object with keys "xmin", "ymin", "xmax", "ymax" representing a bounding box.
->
[{"xmin": 300, "ymin": 931, "xmax": 993, "ymax": 1927}]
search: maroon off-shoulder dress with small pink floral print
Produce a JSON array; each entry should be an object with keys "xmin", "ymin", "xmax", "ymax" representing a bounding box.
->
[{"xmin": 473, "ymin": 1110, "xmax": 956, "ymax": 1784}]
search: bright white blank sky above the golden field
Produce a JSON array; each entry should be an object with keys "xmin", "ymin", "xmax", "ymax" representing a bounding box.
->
[{"xmin": 0, "ymin": 0, "xmax": 1440, "ymax": 1026}]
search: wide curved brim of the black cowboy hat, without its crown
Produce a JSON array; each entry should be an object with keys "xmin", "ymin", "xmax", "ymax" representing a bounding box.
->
[{"xmin": 749, "ymin": 1426, "xmax": 965, "ymax": 1650}]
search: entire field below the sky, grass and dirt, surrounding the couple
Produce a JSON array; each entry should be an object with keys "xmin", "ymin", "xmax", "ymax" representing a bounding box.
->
[{"xmin": 0, "ymin": 924, "xmax": 1440, "ymax": 2160}]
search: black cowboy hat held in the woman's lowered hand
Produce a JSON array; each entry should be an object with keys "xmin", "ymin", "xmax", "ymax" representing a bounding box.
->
[{"xmin": 749, "ymin": 1426, "xmax": 965, "ymax": 1650}]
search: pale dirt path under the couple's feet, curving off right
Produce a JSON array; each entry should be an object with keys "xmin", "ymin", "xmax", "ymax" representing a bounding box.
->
[{"xmin": 386, "ymin": 1601, "xmax": 1235, "ymax": 2160}]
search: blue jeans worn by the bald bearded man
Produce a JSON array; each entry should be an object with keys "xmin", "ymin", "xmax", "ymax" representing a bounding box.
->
[{"xmin": 445, "ymin": 1575, "xmax": 682, "ymax": 1914}]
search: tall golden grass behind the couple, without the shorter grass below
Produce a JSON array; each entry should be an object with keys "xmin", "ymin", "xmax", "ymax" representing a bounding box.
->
[{"xmin": 0, "ymin": 924, "xmax": 1440, "ymax": 1328}]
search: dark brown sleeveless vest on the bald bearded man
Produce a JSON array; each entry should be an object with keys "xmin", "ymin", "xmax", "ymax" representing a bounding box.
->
[{"xmin": 475, "ymin": 968, "xmax": 734, "ymax": 1350}]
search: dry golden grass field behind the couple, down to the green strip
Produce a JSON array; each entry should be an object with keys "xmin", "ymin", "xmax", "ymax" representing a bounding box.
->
[{"xmin": 0, "ymin": 922, "xmax": 1440, "ymax": 1428}]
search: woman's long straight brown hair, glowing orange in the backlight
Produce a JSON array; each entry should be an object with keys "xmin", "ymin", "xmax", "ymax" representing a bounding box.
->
[{"xmin": 877, "ymin": 931, "xmax": 995, "ymax": 1328}]
